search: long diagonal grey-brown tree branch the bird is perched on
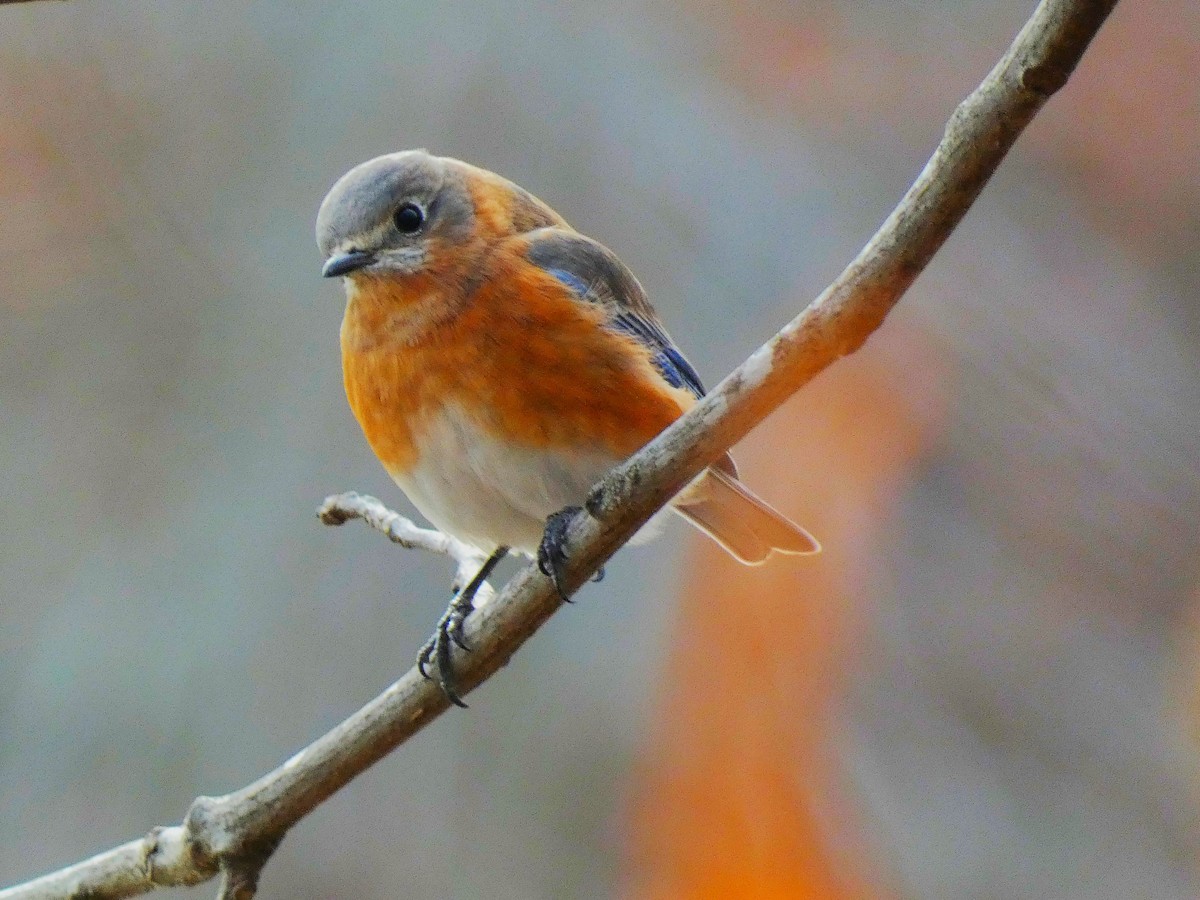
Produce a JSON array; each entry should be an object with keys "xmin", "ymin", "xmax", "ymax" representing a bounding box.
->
[{"xmin": 0, "ymin": 0, "xmax": 1116, "ymax": 900}]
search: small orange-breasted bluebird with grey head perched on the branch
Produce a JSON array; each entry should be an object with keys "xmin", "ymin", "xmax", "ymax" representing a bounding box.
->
[{"xmin": 317, "ymin": 150, "xmax": 820, "ymax": 706}]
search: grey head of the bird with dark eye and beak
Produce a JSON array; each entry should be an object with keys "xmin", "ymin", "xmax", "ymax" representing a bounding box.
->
[{"xmin": 317, "ymin": 150, "xmax": 474, "ymax": 278}]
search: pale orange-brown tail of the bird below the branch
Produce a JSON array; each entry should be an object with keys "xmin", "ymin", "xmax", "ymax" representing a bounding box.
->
[{"xmin": 674, "ymin": 461, "xmax": 821, "ymax": 565}]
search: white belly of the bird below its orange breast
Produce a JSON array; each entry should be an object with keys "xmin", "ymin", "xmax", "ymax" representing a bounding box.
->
[{"xmin": 394, "ymin": 409, "xmax": 619, "ymax": 556}]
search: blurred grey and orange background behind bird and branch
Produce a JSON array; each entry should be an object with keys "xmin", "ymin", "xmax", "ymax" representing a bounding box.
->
[{"xmin": 0, "ymin": 0, "xmax": 1200, "ymax": 900}]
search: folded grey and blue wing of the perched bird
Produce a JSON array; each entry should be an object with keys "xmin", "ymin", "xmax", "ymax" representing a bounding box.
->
[{"xmin": 528, "ymin": 228, "xmax": 704, "ymax": 397}]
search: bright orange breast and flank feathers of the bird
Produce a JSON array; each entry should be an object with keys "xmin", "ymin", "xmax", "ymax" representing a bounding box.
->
[{"xmin": 342, "ymin": 259, "xmax": 694, "ymax": 474}]
